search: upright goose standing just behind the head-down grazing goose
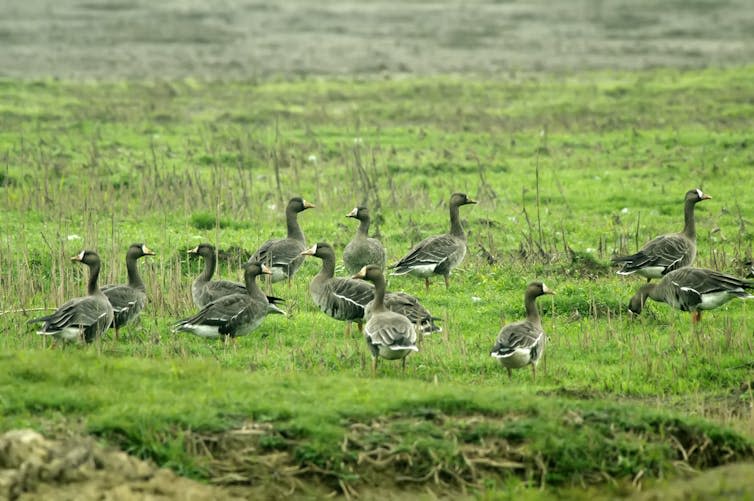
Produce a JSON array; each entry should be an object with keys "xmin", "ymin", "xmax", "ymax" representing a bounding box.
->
[{"xmin": 612, "ymin": 189, "xmax": 712, "ymax": 282}]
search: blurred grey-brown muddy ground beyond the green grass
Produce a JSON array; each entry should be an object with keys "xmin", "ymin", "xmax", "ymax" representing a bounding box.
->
[{"xmin": 0, "ymin": 0, "xmax": 754, "ymax": 79}]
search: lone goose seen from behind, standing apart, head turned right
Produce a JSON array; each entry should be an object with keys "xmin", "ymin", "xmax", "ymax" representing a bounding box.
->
[{"xmin": 490, "ymin": 282, "xmax": 555, "ymax": 380}]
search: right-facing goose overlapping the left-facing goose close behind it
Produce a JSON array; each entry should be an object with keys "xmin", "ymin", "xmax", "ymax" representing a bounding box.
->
[{"xmin": 172, "ymin": 262, "xmax": 271, "ymax": 341}]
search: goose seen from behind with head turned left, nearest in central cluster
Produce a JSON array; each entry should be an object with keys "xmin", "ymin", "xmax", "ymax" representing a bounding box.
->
[{"xmin": 352, "ymin": 264, "xmax": 419, "ymax": 375}]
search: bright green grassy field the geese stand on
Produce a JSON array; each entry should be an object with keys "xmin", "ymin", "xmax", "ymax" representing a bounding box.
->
[{"xmin": 0, "ymin": 67, "xmax": 754, "ymax": 497}]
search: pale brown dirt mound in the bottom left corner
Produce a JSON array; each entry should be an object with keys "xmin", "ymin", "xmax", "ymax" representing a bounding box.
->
[{"xmin": 0, "ymin": 430, "xmax": 240, "ymax": 501}]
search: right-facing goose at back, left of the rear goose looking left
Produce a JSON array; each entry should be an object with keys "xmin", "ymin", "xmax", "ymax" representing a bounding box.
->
[{"xmin": 249, "ymin": 197, "xmax": 315, "ymax": 286}]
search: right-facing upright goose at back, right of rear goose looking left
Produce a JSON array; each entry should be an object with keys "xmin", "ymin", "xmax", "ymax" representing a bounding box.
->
[{"xmin": 390, "ymin": 193, "xmax": 476, "ymax": 291}]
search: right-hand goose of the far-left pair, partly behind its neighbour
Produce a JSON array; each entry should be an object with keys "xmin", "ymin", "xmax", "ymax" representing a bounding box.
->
[{"xmin": 102, "ymin": 244, "xmax": 154, "ymax": 339}]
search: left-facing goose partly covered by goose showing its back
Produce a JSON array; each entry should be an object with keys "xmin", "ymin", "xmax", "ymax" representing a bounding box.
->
[{"xmin": 301, "ymin": 242, "xmax": 374, "ymax": 334}]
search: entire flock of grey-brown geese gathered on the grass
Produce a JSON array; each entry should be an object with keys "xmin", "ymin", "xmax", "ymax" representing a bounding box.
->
[{"xmin": 29, "ymin": 189, "xmax": 754, "ymax": 378}]
